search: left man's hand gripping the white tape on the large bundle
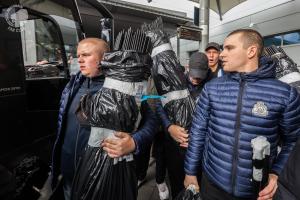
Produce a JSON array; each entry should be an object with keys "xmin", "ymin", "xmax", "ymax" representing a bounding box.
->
[{"xmin": 101, "ymin": 132, "xmax": 135, "ymax": 158}]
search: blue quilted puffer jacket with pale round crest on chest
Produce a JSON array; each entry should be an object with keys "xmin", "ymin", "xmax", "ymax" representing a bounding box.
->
[{"xmin": 184, "ymin": 58, "xmax": 300, "ymax": 198}]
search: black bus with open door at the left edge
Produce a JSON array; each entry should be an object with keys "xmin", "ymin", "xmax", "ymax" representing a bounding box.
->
[{"xmin": 0, "ymin": 0, "xmax": 113, "ymax": 200}]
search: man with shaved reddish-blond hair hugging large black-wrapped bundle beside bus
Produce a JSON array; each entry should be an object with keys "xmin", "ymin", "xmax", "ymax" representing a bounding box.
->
[{"xmin": 51, "ymin": 38, "xmax": 156, "ymax": 200}]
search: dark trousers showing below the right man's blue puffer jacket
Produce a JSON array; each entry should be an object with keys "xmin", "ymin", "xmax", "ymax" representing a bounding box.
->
[{"xmin": 200, "ymin": 173, "xmax": 251, "ymax": 200}]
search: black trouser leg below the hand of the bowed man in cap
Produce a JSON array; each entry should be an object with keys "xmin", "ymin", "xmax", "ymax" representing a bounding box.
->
[{"xmin": 165, "ymin": 135, "xmax": 186, "ymax": 199}]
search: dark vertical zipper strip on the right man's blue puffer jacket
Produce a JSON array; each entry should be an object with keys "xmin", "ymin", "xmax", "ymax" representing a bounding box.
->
[{"xmin": 231, "ymin": 79, "xmax": 245, "ymax": 195}]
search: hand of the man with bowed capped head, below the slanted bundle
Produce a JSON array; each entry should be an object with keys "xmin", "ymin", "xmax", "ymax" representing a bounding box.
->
[{"xmin": 168, "ymin": 124, "xmax": 189, "ymax": 147}]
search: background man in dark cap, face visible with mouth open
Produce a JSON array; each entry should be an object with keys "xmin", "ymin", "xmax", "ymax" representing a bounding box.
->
[{"xmin": 205, "ymin": 42, "xmax": 223, "ymax": 79}]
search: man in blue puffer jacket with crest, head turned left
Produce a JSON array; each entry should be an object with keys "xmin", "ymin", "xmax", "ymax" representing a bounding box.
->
[{"xmin": 184, "ymin": 29, "xmax": 300, "ymax": 200}]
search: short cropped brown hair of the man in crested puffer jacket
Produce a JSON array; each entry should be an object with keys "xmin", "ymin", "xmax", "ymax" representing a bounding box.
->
[{"xmin": 227, "ymin": 29, "xmax": 264, "ymax": 58}]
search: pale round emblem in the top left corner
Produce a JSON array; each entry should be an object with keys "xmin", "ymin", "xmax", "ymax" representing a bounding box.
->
[{"xmin": 5, "ymin": 5, "xmax": 28, "ymax": 32}]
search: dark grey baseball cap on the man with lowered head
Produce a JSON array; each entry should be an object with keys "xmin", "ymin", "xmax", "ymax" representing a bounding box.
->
[{"xmin": 189, "ymin": 52, "xmax": 208, "ymax": 80}]
